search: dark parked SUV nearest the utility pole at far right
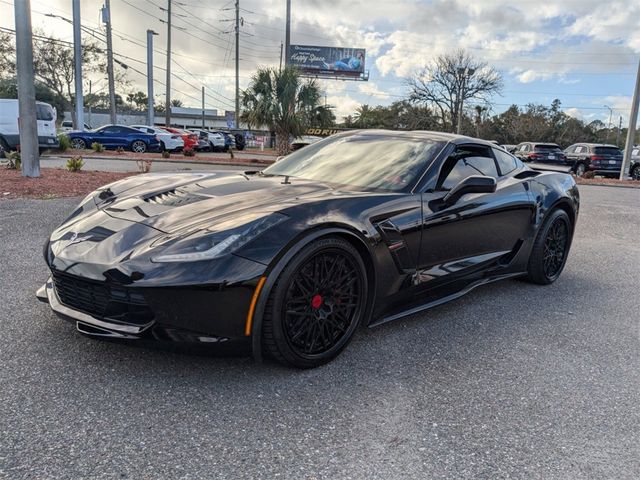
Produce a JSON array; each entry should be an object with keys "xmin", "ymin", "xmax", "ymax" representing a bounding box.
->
[{"xmin": 565, "ymin": 143, "xmax": 622, "ymax": 177}]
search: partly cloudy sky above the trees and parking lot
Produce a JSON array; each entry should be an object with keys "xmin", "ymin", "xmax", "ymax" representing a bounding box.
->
[{"xmin": 0, "ymin": 0, "xmax": 640, "ymax": 125}]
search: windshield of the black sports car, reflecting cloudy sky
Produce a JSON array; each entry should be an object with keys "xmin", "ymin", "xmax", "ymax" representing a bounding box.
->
[{"xmin": 263, "ymin": 133, "xmax": 442, "ymax": 191}]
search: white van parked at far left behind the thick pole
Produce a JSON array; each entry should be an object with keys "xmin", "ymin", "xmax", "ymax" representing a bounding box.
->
[{"xmin": 0, "ymin": 98, "xmax": 59, "ymax": 156}]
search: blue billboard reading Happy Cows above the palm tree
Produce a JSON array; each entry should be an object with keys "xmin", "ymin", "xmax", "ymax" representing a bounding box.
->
[{"xmin": 287, "ymin": 45, "xmax": 365, "ymax": 77}]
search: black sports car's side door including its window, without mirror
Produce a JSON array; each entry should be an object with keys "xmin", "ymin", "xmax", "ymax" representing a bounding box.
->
[{"xmin": 418, "ymin": 144, "xmax": 534, "ymax": 286}]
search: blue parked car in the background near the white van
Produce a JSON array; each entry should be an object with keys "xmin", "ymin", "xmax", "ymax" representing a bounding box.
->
[{"xmin": 67, "ymin": 125, "xmax": 160, "ymax": 153}]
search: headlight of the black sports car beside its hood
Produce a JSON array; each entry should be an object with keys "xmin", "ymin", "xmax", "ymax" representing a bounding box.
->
[{"xmin": 151, "ymin": 213, "xmax": 288, "ymax": 263}]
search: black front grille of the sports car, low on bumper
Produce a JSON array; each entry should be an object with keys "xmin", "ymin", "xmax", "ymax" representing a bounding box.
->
[{"xmin": 51, "ymin": 271, "xmax": 154, "ymax": 325}]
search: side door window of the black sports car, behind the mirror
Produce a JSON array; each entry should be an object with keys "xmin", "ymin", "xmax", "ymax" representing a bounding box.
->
[{"xmin": 437, "ymin": 145, "xmax": 499, "ymax": 190}]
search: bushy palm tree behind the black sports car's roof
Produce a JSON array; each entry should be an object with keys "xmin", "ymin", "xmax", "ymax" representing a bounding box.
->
[{"xmin": 240, "ymin": 67, "xmax": 320, "ymax": 155}]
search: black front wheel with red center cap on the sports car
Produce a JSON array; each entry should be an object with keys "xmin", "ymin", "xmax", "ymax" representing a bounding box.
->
[{"xmin": 262, "ymin": 237, "xmax": 368, "ymax": 368}]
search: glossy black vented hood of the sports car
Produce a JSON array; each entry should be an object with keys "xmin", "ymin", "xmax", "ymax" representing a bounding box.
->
[{"xmin": 67, "ymin": 172, "xmax": 339, "ymax": 234}]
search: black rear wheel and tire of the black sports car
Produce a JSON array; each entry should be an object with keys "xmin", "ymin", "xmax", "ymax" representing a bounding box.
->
[{"xmin": 527, "ymin": 209, "xmax": 573, "ymax": 285}]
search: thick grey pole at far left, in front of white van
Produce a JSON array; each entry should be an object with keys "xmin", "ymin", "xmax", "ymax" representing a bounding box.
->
[{"xmin": 14, "ymin": 0, "xmax": 40, "ymax": 177}]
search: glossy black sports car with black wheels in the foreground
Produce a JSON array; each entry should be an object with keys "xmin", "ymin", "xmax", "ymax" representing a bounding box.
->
[{"xmin": 38, "ymin": 130, "xmax": 579, "ymax": 367}]
